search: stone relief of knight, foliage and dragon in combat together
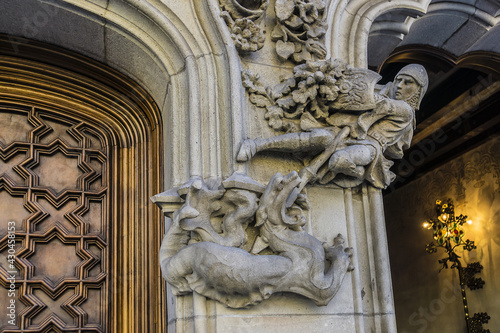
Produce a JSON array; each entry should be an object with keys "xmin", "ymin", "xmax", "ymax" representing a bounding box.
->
[{"xmin": 152, "ymin": 60, "xmax": 428, "ymax": 308}]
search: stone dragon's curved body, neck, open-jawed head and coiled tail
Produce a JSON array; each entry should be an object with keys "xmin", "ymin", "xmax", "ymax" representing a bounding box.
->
[{"xmin": 160, "ymin": 172, "xmax": 352, "ymax": 308}]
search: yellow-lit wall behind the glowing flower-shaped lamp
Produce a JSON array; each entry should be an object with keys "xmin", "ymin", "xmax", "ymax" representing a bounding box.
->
[{"xmin": 384, "ymin": 137, "xmax": 500, "ymax": 333}]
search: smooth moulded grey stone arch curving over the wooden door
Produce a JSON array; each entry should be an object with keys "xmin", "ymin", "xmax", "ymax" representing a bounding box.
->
[{"xmin": 0, "ymin": 0, "xmax": 248, "ymax": 186}]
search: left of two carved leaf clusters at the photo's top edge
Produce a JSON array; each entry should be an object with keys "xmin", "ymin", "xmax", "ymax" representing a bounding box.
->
[{"xmin": 220, "ymin": 0, "xmax": 269, "ymax": 52}]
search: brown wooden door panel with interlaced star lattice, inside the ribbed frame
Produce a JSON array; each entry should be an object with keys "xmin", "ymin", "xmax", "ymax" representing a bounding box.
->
[{"xmin": 0, "ymin": 104, "xmax": 110, "ymax": 333}]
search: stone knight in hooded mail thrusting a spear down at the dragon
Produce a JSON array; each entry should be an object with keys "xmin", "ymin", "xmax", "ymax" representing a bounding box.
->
[{"xmin": 237, "ymin": 64, "xmax": 428, "ymax": 188}]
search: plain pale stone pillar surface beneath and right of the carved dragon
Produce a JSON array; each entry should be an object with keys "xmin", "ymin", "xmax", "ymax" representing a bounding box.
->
[{"xmin": 155, "ymin": 184, "xmax": 396, "ymax": 333}]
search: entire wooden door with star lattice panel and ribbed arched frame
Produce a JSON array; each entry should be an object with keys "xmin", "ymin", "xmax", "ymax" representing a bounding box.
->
[{"xmin": 0, "ymin": 35, "xmax": 167, "ymax": 333}]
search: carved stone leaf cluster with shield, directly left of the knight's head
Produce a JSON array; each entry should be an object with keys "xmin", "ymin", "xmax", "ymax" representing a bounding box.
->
[{"xmin": 242, "ymin": 59, "xmax": 380, "ymax": 132}]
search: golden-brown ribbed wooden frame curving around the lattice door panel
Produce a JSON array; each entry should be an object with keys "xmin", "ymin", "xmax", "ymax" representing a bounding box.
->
[{"xmin": 0, "ymin": 35, "xmax": 167, "ymax": 333}]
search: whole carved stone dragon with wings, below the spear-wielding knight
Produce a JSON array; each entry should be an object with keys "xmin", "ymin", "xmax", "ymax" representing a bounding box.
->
[{"xmin": 153, "ymin": 172, "xmax": 352, "ymax": 308}]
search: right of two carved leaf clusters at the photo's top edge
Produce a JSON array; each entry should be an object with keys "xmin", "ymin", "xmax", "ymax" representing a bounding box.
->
[{"xmin": 271, "ymin": 0, "xmax": 326, "ymax": 63}]
